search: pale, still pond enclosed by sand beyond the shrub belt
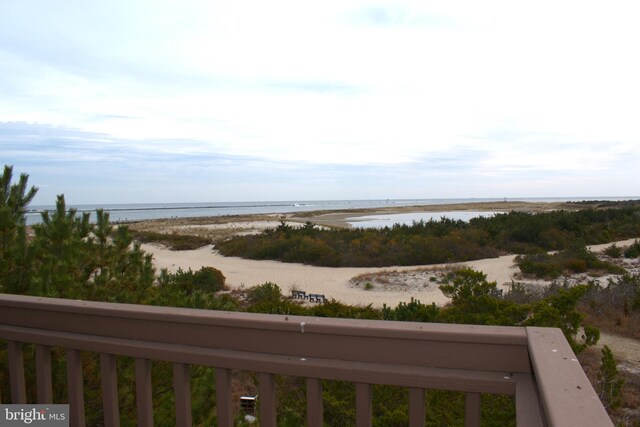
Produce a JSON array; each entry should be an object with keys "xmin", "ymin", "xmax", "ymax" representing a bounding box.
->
[{"xmin": 347, "ymin": 211, "xmax": 500, "ymax": 228}]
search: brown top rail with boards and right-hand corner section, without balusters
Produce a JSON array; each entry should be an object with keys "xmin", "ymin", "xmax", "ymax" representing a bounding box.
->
[{"xmin": 0, "ymin": 294, "xmax": 611, "ymax": 426}]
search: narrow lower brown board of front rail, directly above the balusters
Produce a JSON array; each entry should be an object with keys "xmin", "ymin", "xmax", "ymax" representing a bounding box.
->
[{"xmin": 0, "ymin": 326, "xmax": 515, "ymax": 395}]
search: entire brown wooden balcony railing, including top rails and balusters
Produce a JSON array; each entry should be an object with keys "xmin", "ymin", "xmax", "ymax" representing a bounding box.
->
[{"xmin": 0, "ymin": 294, "xmax": 612, "ymax": 426}]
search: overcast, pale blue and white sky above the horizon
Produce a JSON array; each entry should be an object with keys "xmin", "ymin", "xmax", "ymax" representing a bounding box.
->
[{"xmin": 0, "ymin": 0, "xmax": 640, "ymax": 204}]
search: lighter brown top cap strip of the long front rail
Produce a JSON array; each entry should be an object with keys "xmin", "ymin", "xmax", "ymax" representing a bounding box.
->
[{"xmin": 0, "ymin": 294, "xmax": 527, "ymax": 346}]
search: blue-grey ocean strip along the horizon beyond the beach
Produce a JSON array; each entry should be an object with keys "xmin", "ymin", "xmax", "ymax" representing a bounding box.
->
[{"xmin": 26, "ymin": 197, "xmax": 629, "ymax": 226}]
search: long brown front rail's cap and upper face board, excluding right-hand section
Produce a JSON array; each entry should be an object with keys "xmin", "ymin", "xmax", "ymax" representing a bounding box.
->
[{"xmin": 0, "ymin": 296, "xmax": 530, "ymax": 372}]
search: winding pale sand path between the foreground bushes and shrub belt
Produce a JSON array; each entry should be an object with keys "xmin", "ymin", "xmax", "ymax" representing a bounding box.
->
[{"xmin": 142, "ymin": 239, "xmax": 634, "ymax": 307}]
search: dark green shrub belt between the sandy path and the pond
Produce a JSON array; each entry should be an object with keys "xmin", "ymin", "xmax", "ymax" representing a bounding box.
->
[{"xmin": 217, "ymin": 202, "xmax": 640, "ymax": 267}]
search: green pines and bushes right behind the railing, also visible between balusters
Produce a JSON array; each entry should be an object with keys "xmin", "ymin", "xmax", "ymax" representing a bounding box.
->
[{"xmin": 0, "ymin": 167, "xmax": 640, "ymax": 426}]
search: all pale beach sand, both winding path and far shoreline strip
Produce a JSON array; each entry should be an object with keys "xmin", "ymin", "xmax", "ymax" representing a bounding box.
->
[{"xmin": 135, "ymin": 204, "xmax": 634, "ymax": 307}]
